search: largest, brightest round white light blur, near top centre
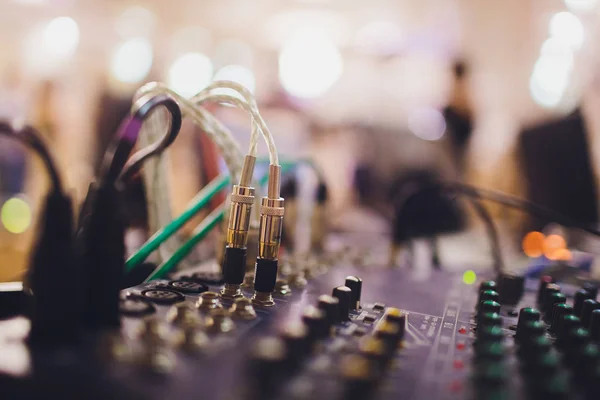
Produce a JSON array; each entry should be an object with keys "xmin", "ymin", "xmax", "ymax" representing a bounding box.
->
[{"xmin": 279, "ymin": 30, "xmax": 344, "ymax": 98}]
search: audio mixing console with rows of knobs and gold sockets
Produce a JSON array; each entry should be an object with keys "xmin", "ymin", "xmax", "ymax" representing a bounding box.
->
[{"xmin": 0, "ymin": 256, "xmax": 600, "ymax": 400}]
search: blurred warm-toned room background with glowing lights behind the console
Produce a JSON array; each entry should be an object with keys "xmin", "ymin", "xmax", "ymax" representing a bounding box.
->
[{"xmin": 0, "ymin": 0, "xmax": 600, "ymax": 280}]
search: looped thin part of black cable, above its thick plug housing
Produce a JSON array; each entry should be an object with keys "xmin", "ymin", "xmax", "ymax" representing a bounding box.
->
[{"xmin": 100, "ymin": 95, "xmax": 182, "ymax": 182}]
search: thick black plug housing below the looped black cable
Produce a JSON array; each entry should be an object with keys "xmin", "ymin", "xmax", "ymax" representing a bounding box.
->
[{"xmin": 76, "ymin": 183, "xmax": 126, "ymax": 331}]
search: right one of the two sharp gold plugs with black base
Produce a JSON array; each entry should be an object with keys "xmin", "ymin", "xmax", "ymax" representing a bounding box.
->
[{"xmin": 252, "ymin": 165, "xmax": 285, "ymax": 307}]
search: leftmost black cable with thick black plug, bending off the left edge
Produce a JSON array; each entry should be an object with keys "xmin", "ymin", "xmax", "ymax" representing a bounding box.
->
[{"xmin": 0, "ymin": 122, "xmax": 81, "ymax": 347}]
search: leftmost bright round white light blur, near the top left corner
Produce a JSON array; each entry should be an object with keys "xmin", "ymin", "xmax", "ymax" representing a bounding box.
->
[{"xmin": 42, "ymin": 17, "xmax": 79, "ymax": 58}]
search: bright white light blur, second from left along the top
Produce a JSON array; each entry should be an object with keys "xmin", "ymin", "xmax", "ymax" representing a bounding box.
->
[{"xmin": 110, "ymin": 37, "xmax": 153, "ymax": 83}]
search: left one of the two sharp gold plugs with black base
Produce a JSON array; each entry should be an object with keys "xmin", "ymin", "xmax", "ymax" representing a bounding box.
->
[{"xmin": 221, "ymin": 155, "xmax": 256, "ymax": 298}]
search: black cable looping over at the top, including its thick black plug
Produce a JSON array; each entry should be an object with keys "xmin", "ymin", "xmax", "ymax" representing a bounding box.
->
[{"xmin": 76, "ymin": 95, "xmax": 181, "ymax": 331}]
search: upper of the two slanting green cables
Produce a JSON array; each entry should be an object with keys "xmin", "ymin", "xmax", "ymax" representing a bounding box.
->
[{"xmin": 125, "ymin": 174, "xmax": 229, "ymax": 272}]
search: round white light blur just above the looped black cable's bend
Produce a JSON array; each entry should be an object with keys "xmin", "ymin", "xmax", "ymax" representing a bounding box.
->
[{"xmin": 168, "ymin": 53, "xmax": 213, "ymax": 97}]
